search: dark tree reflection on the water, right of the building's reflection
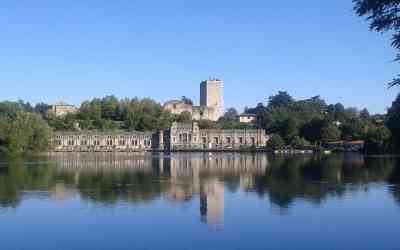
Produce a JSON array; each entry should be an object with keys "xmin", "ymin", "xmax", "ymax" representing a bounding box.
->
[{"xmin": 256, "ymin": 154, "xmax": 394, "ymax": 209}]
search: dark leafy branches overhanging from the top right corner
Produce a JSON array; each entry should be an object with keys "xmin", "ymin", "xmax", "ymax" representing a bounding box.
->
[{"xmin": 353, "ymin": 0, "xmax": 400, "ymax": 87}]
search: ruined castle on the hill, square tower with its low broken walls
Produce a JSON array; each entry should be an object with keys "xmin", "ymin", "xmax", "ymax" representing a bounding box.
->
[{"xmin": 164, "ymin": 79, "xmax": 224, "ymax": 121}]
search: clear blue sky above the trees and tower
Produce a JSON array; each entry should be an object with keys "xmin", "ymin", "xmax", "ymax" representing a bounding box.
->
[{"xmin": 0, "ymin": 0, "xmax": 399, "ymax": 113}]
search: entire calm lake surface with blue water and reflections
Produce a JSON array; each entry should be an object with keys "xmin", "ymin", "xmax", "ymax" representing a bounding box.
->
[{"xmin": 0, "ymin": 153, "xmax": 400, "ymax": 250}]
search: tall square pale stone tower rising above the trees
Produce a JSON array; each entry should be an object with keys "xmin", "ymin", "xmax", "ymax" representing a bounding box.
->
[{"xmin": 200, "ymin": 79, "xmax": 224, "ymax": 121}]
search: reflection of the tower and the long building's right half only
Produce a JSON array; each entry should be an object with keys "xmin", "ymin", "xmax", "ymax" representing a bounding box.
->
[{"xmin": 164, "ymin": 153, "xmax": 268, "ymax": 225}]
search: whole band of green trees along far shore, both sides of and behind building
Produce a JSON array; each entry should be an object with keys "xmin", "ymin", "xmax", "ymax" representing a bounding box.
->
[{"xmin": 0, "ymin": 91, "xmax": 400, "ymax": 155}]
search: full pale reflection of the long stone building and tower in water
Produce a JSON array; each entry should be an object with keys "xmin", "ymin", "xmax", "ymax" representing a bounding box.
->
[{"xmin": 52, "ymin": 153, "xmax": 268, "ymax": 225}]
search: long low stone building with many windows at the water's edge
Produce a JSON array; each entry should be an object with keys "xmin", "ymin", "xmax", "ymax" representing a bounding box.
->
[{"xmin": 51, "ymin": 122, "xmax": 268, "ymax": 152}]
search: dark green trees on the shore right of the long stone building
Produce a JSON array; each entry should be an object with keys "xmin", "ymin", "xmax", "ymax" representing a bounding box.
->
[{"xmin": 241, "ymin": 92, "xmax": 394, "ymax": 152}]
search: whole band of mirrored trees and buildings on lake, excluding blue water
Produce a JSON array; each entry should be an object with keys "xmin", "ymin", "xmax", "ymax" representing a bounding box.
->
[{"xmin": 0, "ymin": 153, "xmax": 400, "ymax": 221}]
